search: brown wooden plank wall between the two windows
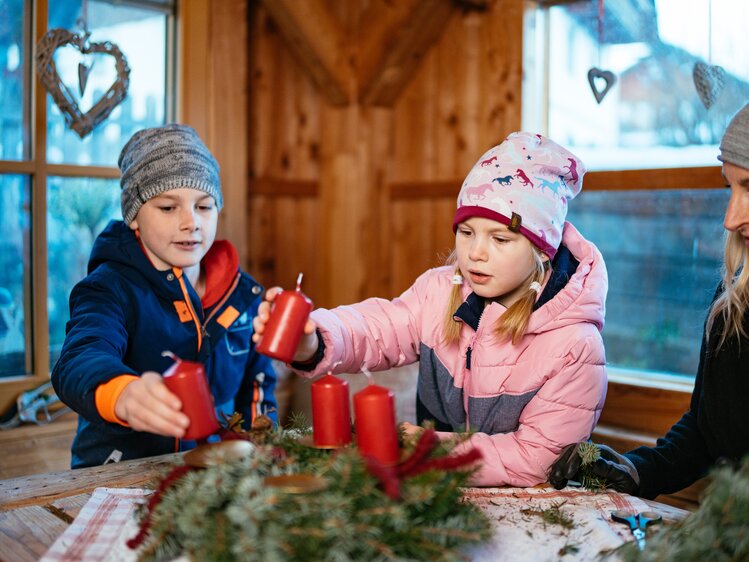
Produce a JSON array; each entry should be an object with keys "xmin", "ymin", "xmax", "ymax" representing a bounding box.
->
[{"xmin": 247, "ymin": 0, "xmax": 522, "ymax": 306}]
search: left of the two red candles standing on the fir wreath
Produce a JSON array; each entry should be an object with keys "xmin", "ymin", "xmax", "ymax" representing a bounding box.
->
[{"xmin": 312, "ymin": 373, "xmax": 351, "ymax": 448}]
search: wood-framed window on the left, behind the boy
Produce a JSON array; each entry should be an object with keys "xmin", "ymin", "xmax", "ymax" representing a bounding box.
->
[{"xmin": 0, "ymin": 0, "xmax": 175, "ymax": 380}]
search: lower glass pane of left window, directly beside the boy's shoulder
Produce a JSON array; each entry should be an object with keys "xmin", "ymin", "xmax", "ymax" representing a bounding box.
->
[{"xmin": 47, "ymin": 177, "xmax": 122, "ymax": 368}]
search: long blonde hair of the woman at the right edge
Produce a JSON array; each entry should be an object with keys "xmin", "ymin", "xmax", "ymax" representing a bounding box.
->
[{"xmin": 705, "ymin": 232, "xmax": 749, "ymax": 349}]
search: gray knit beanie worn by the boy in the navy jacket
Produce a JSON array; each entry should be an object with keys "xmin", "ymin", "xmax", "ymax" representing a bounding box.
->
[{"xmin": 117, "ymin": 124, "xmax": 224, "ymax": 224}]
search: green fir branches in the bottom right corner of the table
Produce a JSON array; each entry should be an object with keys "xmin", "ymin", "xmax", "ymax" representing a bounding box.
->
[{"xmin": 620, "ymin": 456, "xmax": 749, "ymax": 562}]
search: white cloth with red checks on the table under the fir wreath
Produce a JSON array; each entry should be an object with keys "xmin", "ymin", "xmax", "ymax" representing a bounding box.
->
[{"xmin": 41, "ymin": 488, "xmax": 652, "ymax": 562}]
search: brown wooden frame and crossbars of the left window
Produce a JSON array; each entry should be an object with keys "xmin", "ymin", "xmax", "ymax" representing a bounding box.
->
[{"xmin": 0, "ymin": 0, "xmax": 178, "ymax": 412}]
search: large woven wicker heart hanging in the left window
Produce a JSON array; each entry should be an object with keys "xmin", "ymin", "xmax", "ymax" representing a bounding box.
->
[{"xmin": 36, "ymin": 29, "xmax": 130, "ymax": 138}]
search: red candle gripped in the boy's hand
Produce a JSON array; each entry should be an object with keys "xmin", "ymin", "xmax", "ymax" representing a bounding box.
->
[{"xmin": 162, "ymin": 351, "xmax": 219, "ymax": 441}]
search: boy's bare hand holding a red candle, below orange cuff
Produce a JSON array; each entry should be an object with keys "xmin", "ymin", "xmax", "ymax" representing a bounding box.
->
[{"xmin": 114, "ymin": 371, "xmax": 190, "ymax": 438}]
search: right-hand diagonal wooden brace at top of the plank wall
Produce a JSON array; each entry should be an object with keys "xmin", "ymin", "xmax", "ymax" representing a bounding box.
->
[{"xmin": 357, "ymin": 0, "xmax": 455, "ymax": 107}]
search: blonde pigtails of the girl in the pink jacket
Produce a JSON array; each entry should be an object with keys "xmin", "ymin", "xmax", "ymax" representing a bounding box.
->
[{"xmin": 442, "ymin": 244, "xmax": 551, "ymax": 345}]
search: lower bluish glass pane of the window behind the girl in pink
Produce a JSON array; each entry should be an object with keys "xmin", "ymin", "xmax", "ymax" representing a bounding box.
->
[{"xmin": 567, "ymin": 189, "xmax": 729, "ymax": 377}]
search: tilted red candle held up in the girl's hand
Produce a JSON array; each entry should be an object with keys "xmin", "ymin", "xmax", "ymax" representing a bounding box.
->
[{"xmin": 257, "ymin": 273, "xmax": 312, "ymax": 363}]
